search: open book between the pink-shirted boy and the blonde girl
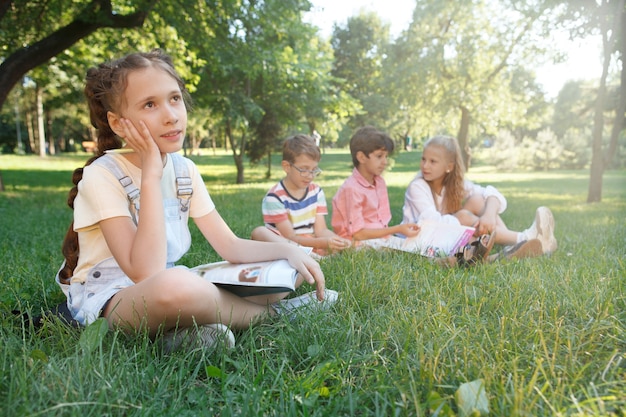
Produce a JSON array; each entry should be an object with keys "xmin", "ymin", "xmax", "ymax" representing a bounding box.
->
[{"xmin": 362, "ymin": 220, "xmax": 476, "ymax": 258}]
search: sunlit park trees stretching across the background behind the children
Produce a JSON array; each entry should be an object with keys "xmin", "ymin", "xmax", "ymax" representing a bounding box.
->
[{"xmin": 0, "ymin": 0, "xmax": 626, "ymax": 201}]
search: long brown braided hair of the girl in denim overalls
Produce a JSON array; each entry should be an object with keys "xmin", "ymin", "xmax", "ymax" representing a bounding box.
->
[{"xmin": 59, "ymin": 49, "xmax": 189, "ymax": 284}]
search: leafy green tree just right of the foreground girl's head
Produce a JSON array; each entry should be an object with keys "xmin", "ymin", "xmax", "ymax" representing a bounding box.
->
[{"xmin": 171, "ymin": 0, "xmax": 330, "ymax": 183}]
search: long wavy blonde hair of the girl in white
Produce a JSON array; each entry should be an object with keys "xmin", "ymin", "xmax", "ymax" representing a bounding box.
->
[{"xmin": 424, "ymin": 136, "xmax": 465, "ymax": 214}]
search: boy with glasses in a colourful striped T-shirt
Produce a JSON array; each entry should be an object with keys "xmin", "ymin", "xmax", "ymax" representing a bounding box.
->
[{"xmin": 252, "ymin": 134, "xmax": 351, "ymax": 256}]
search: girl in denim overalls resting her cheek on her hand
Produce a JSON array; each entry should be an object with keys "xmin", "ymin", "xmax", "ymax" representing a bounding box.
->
[{"xmin": 57, "ymin": 50, "xmax": 337, "ymax": 351}]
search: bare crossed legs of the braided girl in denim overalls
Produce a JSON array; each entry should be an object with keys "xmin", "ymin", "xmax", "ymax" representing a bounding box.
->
[{"xmin": 104, "ymin": 268, "xmax": 269, "ymax": 336}]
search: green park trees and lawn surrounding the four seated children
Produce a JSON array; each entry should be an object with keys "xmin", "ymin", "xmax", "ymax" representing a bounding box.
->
[{"xmin": 0, "ymin": 0, "xmax": 626, "ymax": 416}]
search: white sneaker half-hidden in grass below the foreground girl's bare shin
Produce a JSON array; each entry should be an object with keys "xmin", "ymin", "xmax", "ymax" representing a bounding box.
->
[{"xmin": 161, "ymin": 323, "xmax": 235, "ymax": 353}]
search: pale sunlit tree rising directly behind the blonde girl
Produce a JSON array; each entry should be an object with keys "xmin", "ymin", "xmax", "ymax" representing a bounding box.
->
[{"xmin": 394, "ymin": 0, "xmax": 546, "ymax": 167}]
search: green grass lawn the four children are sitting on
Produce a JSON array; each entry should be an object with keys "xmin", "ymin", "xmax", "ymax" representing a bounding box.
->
[{"xmin": 0, "ymin": 150, "xmax": 626, "ymax": 416}]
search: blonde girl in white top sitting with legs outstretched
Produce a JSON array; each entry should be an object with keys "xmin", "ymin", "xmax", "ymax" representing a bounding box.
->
[{"xmin": 402, "ymin": 136, "xmax": 557, "ymax": 259}]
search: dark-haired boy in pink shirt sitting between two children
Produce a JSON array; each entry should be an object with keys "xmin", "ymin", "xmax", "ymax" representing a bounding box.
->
[{"xmin": 331, "ymin": 126, "xmax": 419, "ymax": 240}]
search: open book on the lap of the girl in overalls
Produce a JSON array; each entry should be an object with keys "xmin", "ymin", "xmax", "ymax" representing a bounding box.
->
[{"xmin": 191, "ymin": 259, "xmax": 298, "ymax": 297}]
